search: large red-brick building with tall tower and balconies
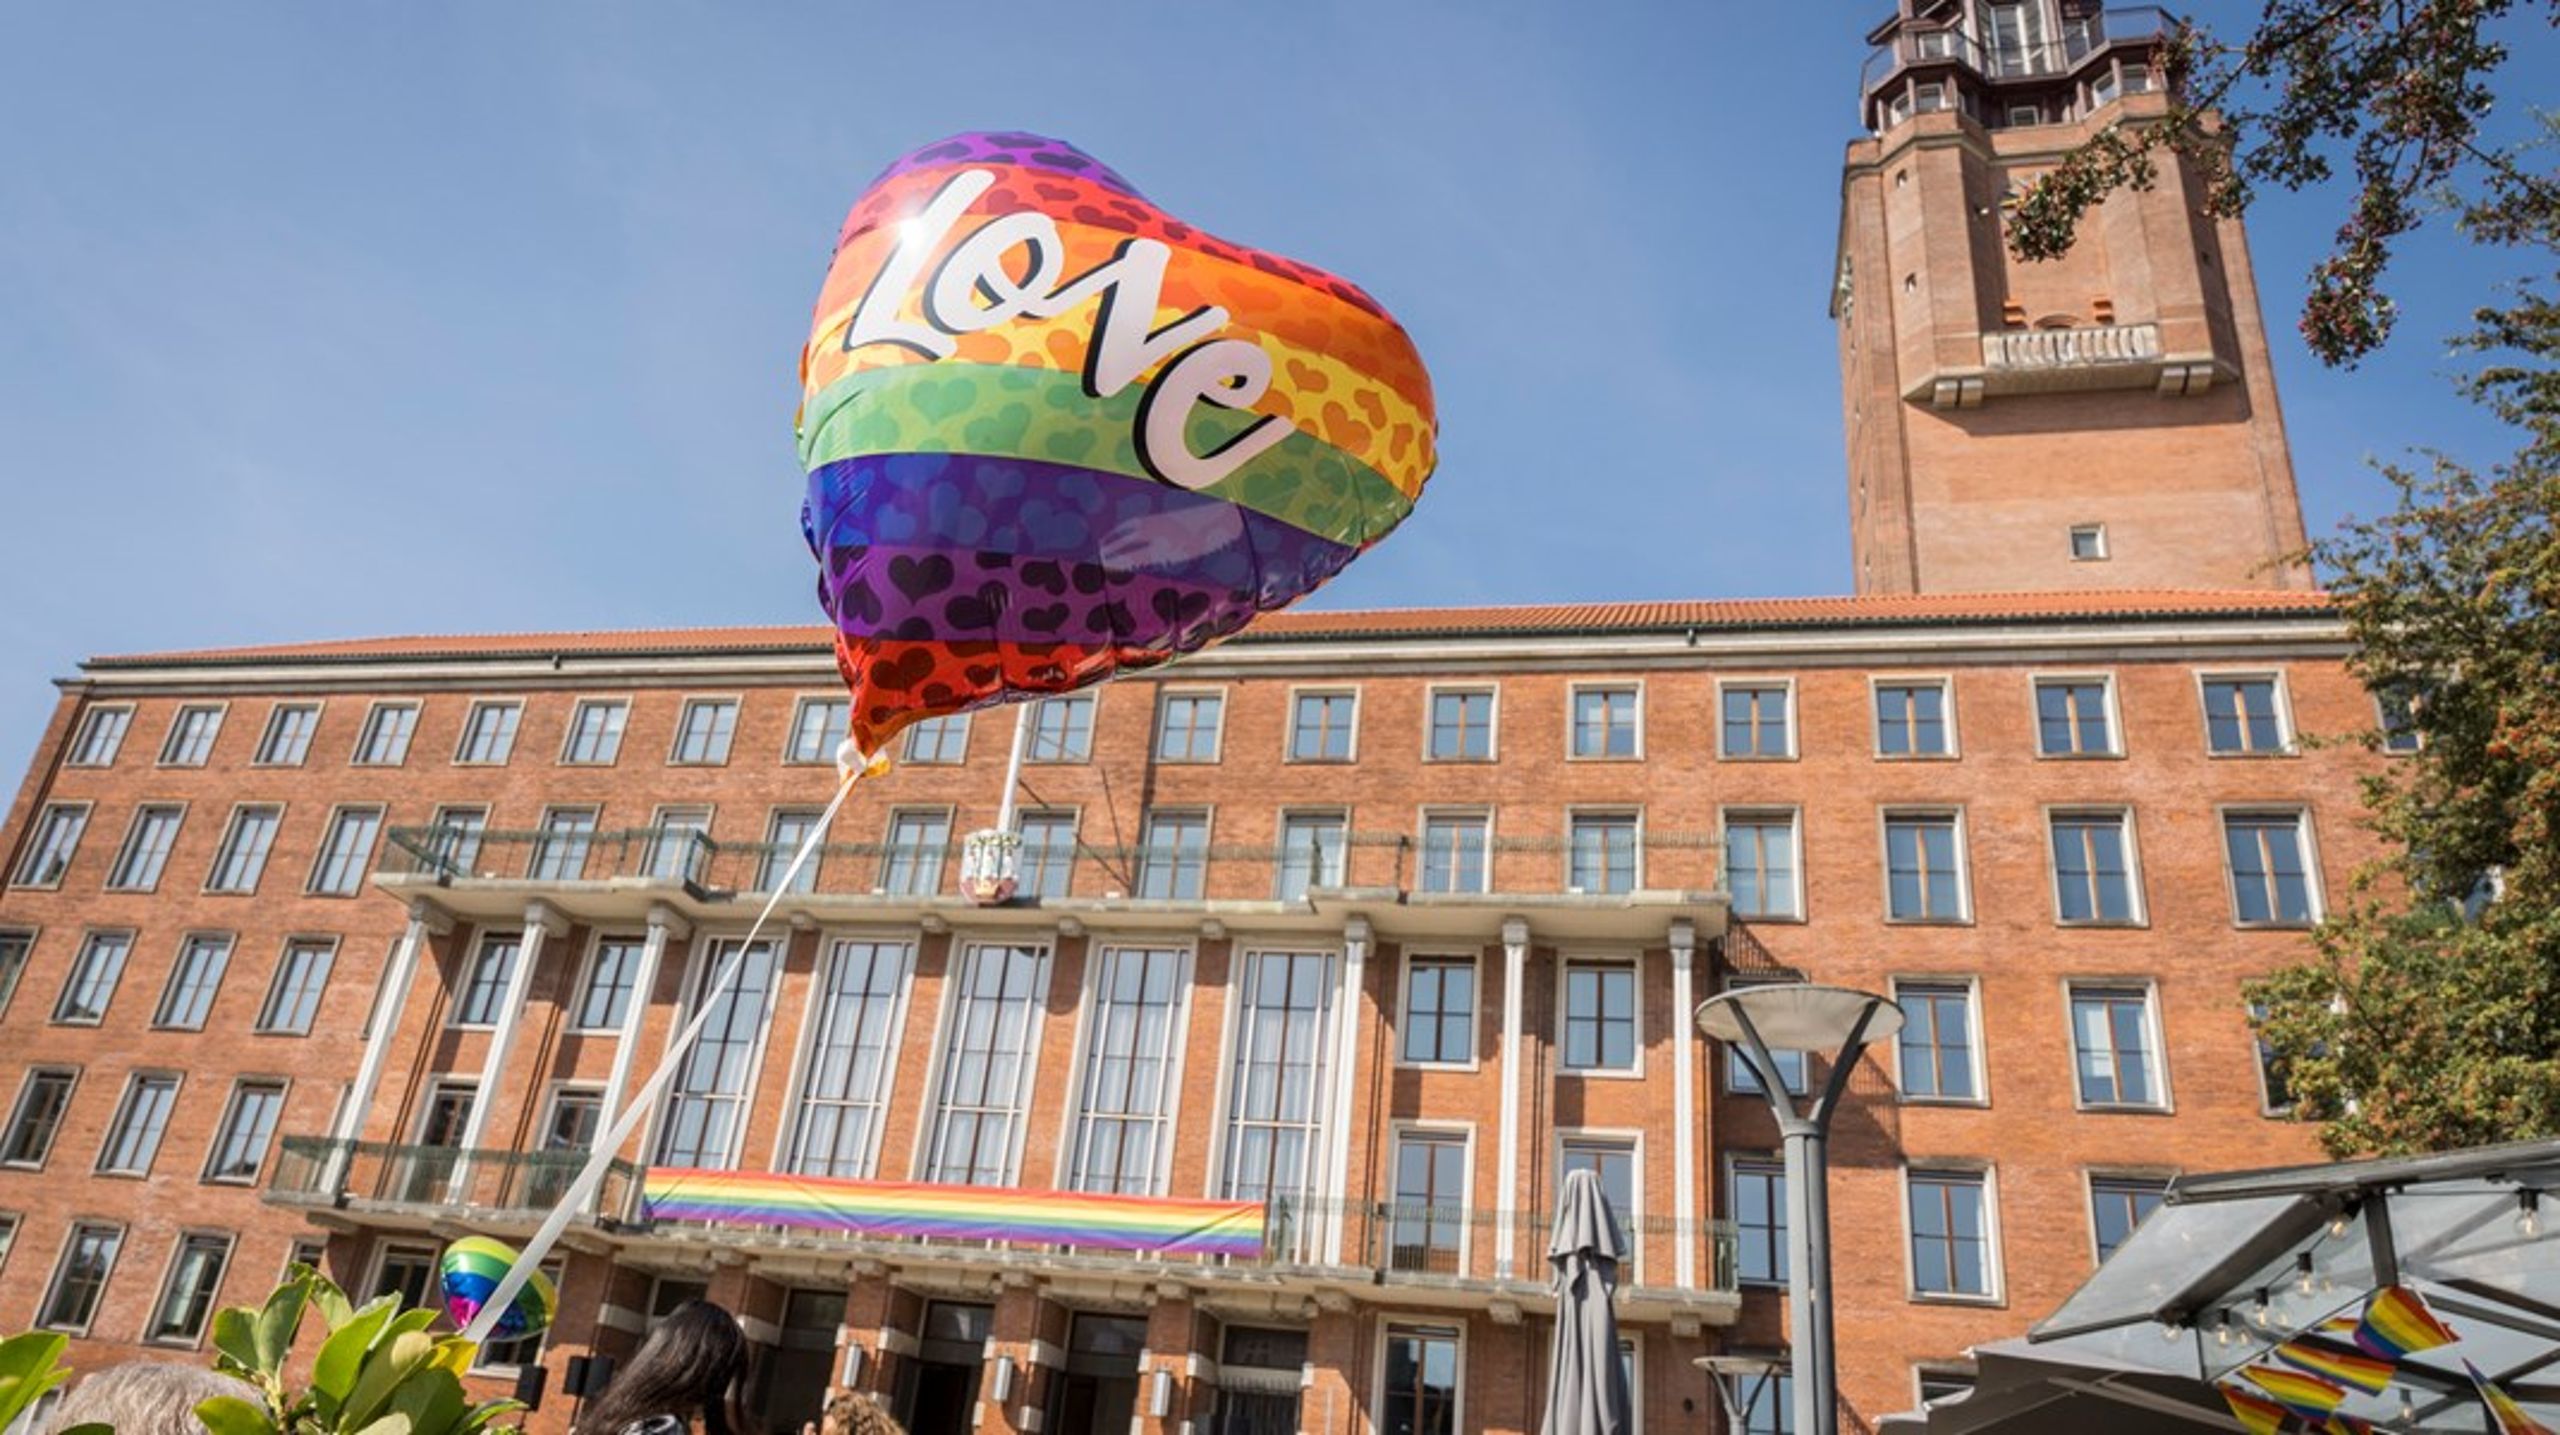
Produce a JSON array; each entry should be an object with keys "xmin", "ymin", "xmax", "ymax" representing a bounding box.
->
[{"xmin": 0, "ymin": 0, "xmax": 2386, "ymax": 1435}]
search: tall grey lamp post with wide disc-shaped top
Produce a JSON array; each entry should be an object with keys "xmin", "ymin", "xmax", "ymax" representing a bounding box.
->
[{"xmin": 1697, "ymin": 982, "xmax": 1902, "ymax": 1435}]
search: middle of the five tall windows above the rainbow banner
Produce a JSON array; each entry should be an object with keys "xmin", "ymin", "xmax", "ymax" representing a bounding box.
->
[{"xmin": 924, "ymin": 941, "xmax": 1050, "ymax": 1187}]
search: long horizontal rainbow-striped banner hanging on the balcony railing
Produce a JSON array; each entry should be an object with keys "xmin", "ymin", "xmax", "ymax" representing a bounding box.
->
[{"xmin": 640, "ymin": 1166, "xmax": 1262, "ymax": 1261}]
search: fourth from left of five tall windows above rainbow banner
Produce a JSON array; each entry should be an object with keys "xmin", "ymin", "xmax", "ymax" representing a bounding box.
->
[{"xmin": 1068, "ymin": 946, "xmax": 1183, "ymax": 1195}]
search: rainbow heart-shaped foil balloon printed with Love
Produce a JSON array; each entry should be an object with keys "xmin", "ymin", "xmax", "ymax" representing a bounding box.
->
[{"xmin": 799, "ymin": 133, "xmax": 1436, "ymax": 752}]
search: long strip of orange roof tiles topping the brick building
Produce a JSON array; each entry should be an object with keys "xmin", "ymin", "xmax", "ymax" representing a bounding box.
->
[{"xmin": 84, "ymin": 588, "xmax": 2330, "ymax": 668}]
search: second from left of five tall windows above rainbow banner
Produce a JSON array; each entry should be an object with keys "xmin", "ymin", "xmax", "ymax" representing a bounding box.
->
[{"xmin": 783, "ymin": 939, "xmax": 914, "ymax": 1179}]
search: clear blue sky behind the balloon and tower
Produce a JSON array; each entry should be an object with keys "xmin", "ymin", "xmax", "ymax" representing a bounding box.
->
[{"xmin": 0, "ymin": 0, "xmax": 2560, "ymax": 775}]
